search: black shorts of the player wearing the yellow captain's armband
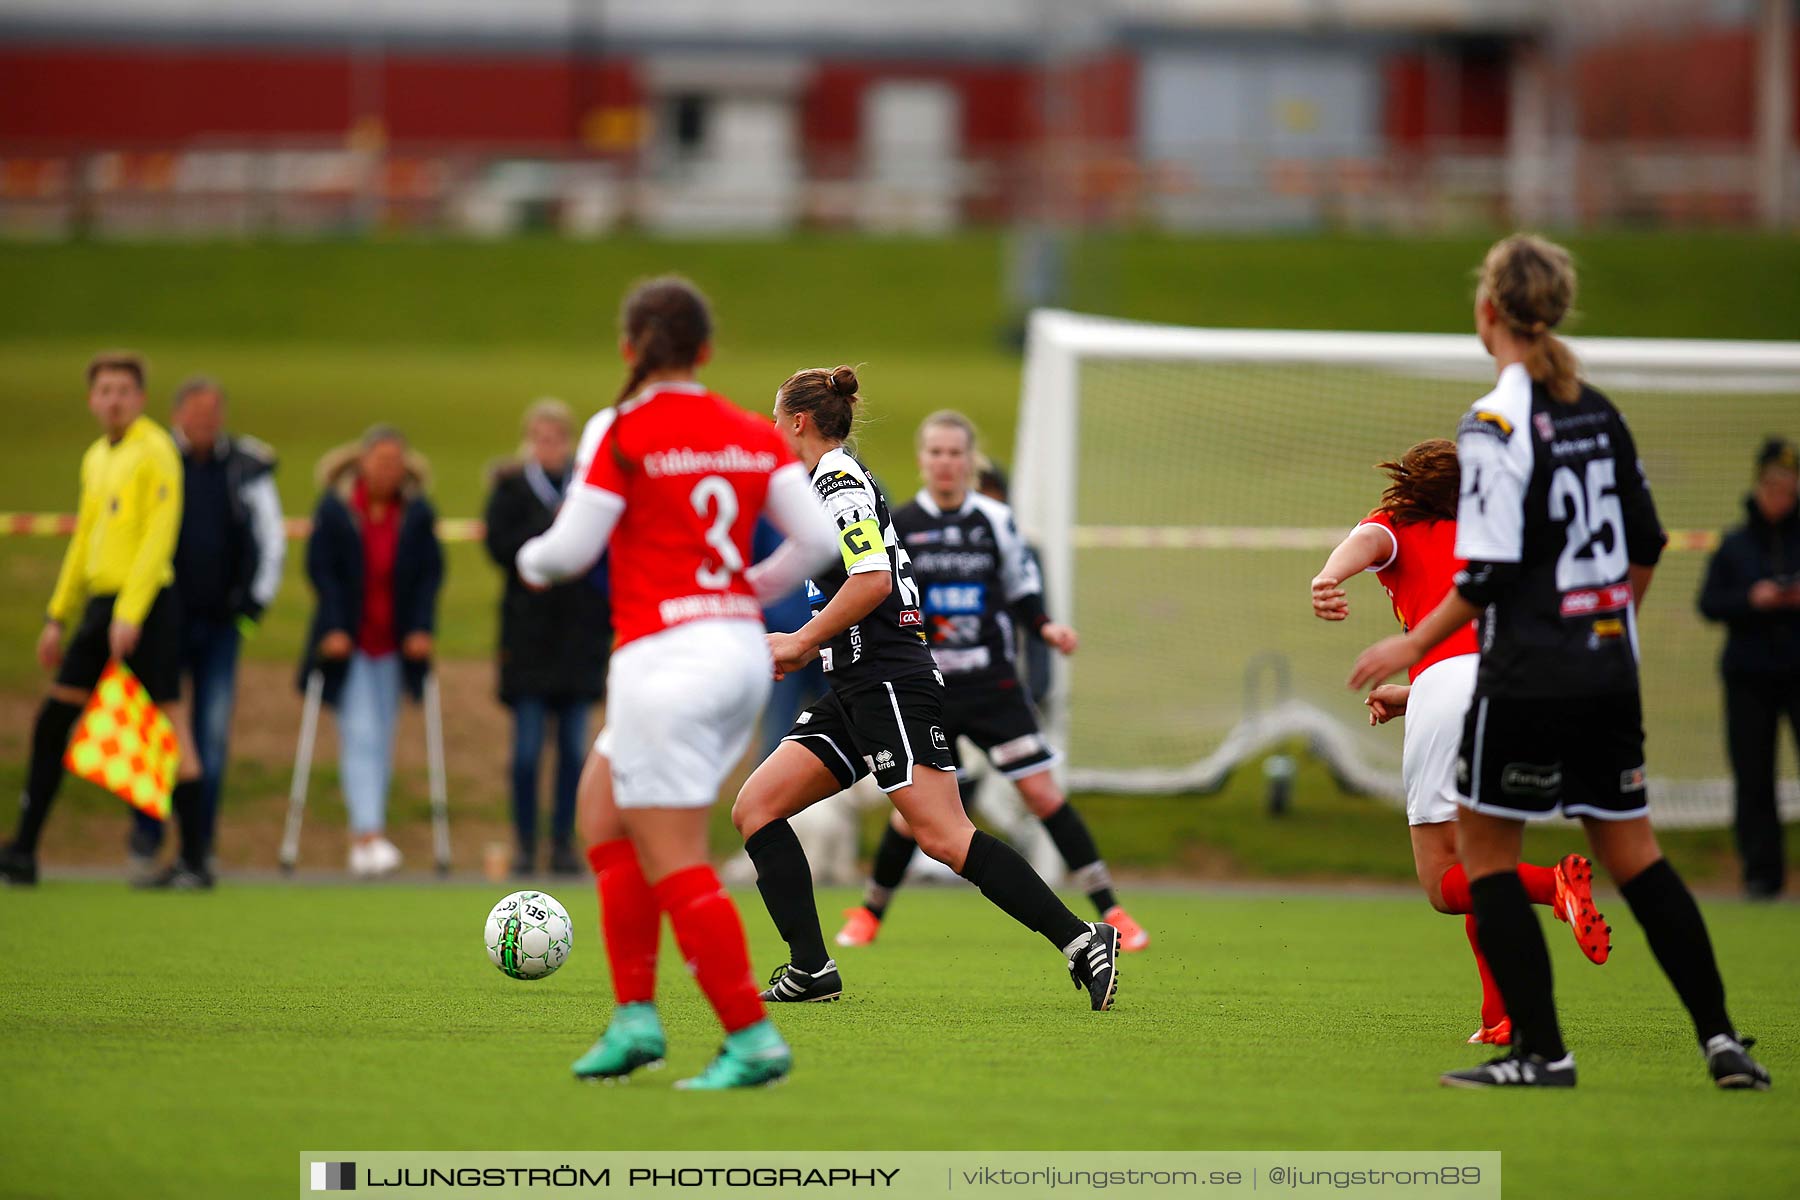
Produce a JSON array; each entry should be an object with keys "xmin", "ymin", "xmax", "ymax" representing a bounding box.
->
[{"xmin": 783, "ymin": 673, "xmax": 956, "ymax": 792}]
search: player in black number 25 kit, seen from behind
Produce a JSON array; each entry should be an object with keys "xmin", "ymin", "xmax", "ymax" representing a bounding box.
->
[{"xmin": 1350, "ymin": 236, "xmax": 1769, "ymax": 1088}]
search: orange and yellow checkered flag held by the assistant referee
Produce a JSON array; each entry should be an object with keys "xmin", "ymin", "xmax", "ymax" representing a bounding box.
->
[{"xmin": 63, "ymin": 662, "xmax": 182, "ymax": 820}]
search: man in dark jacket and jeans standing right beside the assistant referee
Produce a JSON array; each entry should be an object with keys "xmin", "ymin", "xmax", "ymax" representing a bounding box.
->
[{"xmin": 131, "ymin": 376, "xmax": 288, "ymax": 887}]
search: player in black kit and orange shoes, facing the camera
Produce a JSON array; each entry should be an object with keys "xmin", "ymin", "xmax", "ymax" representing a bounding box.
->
[{"xmin": 837, "ymin": 410, "xmax": 1150, "ymax": 950}]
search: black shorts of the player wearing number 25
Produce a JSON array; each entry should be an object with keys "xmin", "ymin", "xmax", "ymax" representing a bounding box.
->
[{"xmin": 1456, "ymin": 691, "xmax": 1651, "ymax": 820}]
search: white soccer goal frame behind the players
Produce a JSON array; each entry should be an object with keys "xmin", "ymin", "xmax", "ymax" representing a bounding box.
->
[{"xmin": 1012, "ymin": 309, "xmax": 1800, "ymax": 826}]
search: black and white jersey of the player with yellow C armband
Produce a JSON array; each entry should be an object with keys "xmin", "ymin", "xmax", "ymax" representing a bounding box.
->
[{"xmin": 806, "ymin": 446, "xmax": 936, "ymax": 693}]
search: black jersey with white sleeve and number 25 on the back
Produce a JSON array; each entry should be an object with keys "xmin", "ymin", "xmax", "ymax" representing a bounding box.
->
[{"xmin": 1456, "ymin": 363, "xmax": 1665, "ymax": 696}]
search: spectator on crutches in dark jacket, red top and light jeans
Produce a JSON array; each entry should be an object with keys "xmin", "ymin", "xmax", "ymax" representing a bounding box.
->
[{"xmin": 301, "ymin": 425, "xmax": 445, "ymax": 876}]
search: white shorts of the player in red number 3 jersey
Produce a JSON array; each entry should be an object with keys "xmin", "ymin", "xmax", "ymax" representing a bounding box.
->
[{"xmin": 594, "ymin": 621, "xmax": 774, "ymax": 808}]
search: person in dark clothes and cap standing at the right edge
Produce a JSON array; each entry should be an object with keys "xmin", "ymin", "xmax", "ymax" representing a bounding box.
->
[{"xmin": 1699, "ymin": 437, "xmax": 1800, "ymax": 900}]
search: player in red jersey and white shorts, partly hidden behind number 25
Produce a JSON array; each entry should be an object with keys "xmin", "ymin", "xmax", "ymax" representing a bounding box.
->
[{"xmin": 1312, "ymin": 439, "xmax": 1611, "ymax": 1045}]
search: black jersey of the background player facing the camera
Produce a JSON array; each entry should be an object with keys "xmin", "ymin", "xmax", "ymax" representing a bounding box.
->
[{"xmin": 895, "ymin": 491, "xmax": 1044, "ymax": 684}]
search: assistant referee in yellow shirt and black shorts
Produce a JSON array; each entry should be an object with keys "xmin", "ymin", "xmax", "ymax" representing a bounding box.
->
[{"xmin": 0, "ymin": 354, "xmax": 198, "ymax": 883}]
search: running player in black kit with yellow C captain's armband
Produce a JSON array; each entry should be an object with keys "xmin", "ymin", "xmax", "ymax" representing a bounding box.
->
[{"xmin": 731, "ymin": 367, "xmax": 1120, "ymax": 1011}]
